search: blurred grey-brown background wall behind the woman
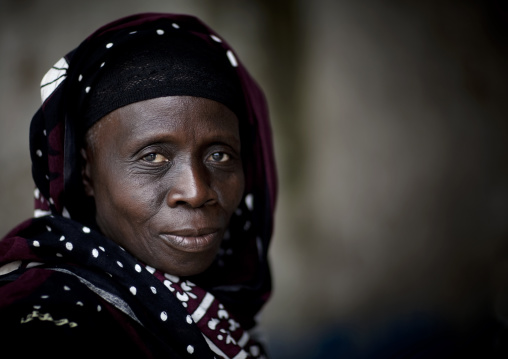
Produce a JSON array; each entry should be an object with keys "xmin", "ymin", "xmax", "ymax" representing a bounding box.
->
[{"xmin": 0, "ymin": 0, "xmax": 508, "ymax": 359}]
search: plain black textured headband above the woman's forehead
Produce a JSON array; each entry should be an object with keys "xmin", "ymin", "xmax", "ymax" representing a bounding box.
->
[{"xmin": 79, "ymin": 25, "xmax": 244, "ymax": 130}]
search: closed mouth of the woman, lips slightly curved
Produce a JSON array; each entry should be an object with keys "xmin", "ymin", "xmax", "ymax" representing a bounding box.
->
[{"xmin": 161, "ymin": 228, "xmax": 222, "ymax": 253}]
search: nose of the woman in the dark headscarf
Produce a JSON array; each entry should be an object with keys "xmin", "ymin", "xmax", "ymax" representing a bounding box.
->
[{"xmin": 167, "ymin": 164, "xmax": 217, "ymax": 208}]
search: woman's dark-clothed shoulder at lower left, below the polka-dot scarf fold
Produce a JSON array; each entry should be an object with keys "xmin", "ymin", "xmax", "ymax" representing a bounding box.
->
[{"xmin": 0, "ymin": 268, "xmax": 153, "ymax": 358}]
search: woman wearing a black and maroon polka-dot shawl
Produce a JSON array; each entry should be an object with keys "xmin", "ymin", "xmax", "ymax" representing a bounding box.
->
[{"xmin": 0, "ymin": 14, "xmax": 276, "ymax": 358}]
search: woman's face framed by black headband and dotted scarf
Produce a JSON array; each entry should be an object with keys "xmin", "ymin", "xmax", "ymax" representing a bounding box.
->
[{"xmin": 82, "ymin": 96, "xmax": 244, "ymax": 276}]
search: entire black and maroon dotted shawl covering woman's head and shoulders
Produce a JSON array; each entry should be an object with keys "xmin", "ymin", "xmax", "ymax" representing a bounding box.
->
[{"xmin": 0, "ymin": 13, "xmax": 277, "ymax": 358}]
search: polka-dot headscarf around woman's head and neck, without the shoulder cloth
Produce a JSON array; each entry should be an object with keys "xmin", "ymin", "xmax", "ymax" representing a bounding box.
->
[{"xmin": 0, "ymin": 13, "xmax": 277, "ymax": 357}]
